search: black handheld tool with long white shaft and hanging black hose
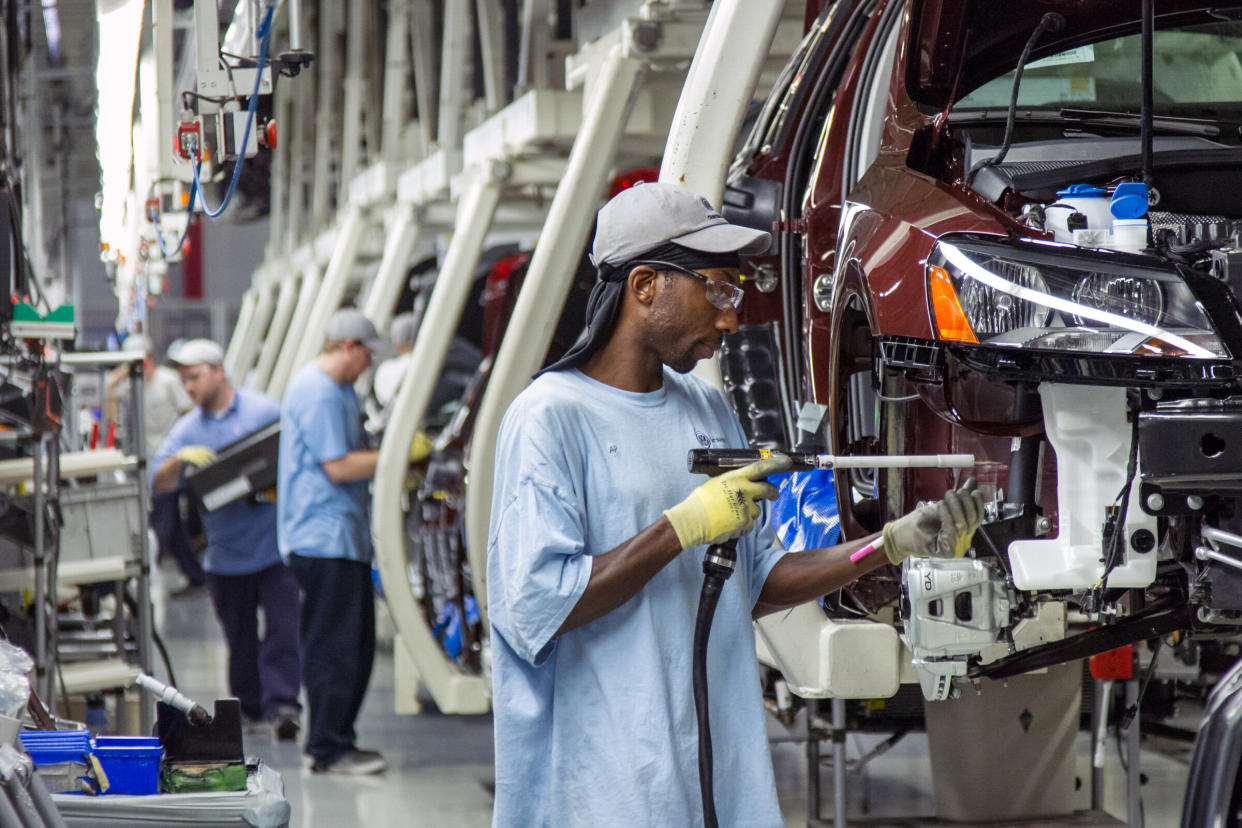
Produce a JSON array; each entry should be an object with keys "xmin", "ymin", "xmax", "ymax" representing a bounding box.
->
[{"xmin": 688, "ymin": 448, "xmax": 975, "ymax": 828}]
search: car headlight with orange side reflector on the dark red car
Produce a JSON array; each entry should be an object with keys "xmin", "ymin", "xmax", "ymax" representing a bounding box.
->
[{"xmin": 927, "ymin": 236, "xmax": 1228, "ymax": 359}]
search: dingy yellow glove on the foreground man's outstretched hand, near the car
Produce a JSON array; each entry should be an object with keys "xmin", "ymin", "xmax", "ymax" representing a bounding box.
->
[{"xmin": 884, "ymin": 478, "xmax": 984, "ymax": 565}]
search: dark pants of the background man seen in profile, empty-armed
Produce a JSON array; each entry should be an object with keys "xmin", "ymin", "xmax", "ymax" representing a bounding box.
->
[{"xmin": 289, "ymin": 555, "xmax": 375, "ymax": 763}]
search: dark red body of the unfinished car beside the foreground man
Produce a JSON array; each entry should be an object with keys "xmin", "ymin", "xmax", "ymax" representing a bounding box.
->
[{"xmin": 725, "ymin": 0, "xmax": 1233, "ymax": 538}]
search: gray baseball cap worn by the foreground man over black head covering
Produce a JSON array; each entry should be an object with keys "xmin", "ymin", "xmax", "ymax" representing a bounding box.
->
[{"xmin": 591, "ymin": 182, "xmax": 771, "ymax": 267}]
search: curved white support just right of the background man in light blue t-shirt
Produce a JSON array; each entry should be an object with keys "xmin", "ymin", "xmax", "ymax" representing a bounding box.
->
[{"xmin": 371, "ymin": 168, "xmax": 502, "ymax": 713}]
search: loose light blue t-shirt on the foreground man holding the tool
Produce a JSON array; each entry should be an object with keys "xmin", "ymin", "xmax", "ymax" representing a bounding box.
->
[{"xmin": 487, "ymin": 370, "xmax": 784, "ymax": 828}]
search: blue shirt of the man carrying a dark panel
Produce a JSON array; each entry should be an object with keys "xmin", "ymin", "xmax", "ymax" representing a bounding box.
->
[{"xmin": 152, "ymin": 387, "xmax": 281, "ymax": 575}]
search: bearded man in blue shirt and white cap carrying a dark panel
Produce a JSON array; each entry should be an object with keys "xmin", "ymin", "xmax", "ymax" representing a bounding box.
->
[{"xmin": 152, "ymin": 339, "xmax": 302, "ymax": 740}]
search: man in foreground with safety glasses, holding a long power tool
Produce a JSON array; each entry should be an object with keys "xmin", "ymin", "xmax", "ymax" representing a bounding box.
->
[{"xmin": 487, "ymin": 184, "xmax": 982, "ymax": 828}]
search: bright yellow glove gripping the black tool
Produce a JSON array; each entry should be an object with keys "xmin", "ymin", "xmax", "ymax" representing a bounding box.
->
[{"xmin": 664, "ymin": 454, "xmax": 790, "ymax": 549}]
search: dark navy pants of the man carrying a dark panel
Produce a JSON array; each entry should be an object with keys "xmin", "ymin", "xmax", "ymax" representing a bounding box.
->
[{"xmin": 207, "ymin": 564, "xmax": 301, "ymax": 719}]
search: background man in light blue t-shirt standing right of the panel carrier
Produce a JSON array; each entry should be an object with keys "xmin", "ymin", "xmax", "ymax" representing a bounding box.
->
[{"xmin": 278, "ymin": 308, "xmax": 388, "ymax": 775}]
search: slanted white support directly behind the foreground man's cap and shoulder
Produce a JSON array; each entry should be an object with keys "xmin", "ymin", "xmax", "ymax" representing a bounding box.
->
[{"xmin": 462, "ymin": 50, "xmax": 642, "ymax": 628}]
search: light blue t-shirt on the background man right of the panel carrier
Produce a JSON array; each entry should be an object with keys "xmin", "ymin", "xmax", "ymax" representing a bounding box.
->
[{"xmin": 277, "ymin": 362, "xmax": 371, "ymax": 564}]
